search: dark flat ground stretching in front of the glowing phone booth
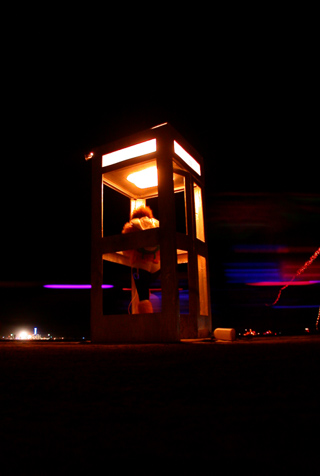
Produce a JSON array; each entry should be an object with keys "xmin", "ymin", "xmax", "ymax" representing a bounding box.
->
[{"xmin": 0, "ymin": 335, "xmax": 320, "ymax": 475}]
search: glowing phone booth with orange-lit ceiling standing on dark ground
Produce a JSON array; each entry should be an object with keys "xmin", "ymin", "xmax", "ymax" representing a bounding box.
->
[{"xmin": 89, "ymin": 123, "xmax": 212, "ymax": 343}]
